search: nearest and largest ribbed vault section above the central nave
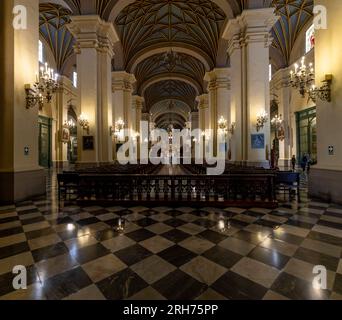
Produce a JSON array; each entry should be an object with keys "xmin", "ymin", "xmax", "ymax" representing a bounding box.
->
[{"xmin": 115, "ymin": 0, "xmax": 226, "ymax": 66}]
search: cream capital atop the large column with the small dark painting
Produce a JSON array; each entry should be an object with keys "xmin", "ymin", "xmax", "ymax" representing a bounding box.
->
[{"xmin": 67, "ymin": 15, "xmax": 120, "ymax": 56}]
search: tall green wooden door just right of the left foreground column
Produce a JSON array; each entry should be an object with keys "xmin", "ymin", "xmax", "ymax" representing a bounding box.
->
[{"xmin": 38, "ymin": 117, "xmax": 51, "ymax": 168}]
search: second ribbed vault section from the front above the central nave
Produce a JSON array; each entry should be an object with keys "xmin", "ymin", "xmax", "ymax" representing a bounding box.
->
[{"xmin": 135, "ymin": 51, "xmax": 206, "ymax": 94}]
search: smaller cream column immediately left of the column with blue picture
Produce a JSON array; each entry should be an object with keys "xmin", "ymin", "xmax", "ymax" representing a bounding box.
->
[{"xmin": 204, "ymin": 68, "xmax": 230, "ymax": 155}]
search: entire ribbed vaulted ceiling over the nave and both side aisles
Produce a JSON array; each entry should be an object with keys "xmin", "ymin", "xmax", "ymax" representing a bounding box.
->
[{"xmin": 40, "ymin": 0, "xmax": 313, "ymax": 124}]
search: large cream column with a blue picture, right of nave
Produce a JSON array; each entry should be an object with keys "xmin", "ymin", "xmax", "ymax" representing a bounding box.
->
[{"xmin": 223, "ymin": 8, "xmax": 279, "ymax": 166}]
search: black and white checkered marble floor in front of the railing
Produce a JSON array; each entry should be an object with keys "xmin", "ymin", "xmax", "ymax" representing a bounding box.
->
[{"xmin": 0, "ymin": 175, "xmax": 342, "ymax": 300}]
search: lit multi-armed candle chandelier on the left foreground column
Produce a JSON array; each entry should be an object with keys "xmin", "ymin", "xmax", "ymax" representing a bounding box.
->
[{"xmin": 25, "ymin": 63, "xmax": 59, "ymax": 110}]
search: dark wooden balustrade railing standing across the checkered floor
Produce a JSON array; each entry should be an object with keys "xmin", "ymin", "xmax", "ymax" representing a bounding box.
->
[{"xmin": 58, "ymin": 171, "xmax": 277, "ymax": 207}]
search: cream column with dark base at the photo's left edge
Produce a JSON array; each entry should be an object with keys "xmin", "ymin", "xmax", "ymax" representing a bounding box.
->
[{"xmin": 0, "ymin": 0, "xmax": 46, "ymax": 203}]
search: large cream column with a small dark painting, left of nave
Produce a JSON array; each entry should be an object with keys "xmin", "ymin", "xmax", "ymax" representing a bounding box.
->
[{"xmin": 68, "ymin": 15, "xmax": 119, "ymax": 164}]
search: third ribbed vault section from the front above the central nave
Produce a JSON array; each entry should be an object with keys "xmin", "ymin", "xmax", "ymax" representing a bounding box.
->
[{"xmin": 145, "ymin": 80, "xmax": 197, "ymax": 111}]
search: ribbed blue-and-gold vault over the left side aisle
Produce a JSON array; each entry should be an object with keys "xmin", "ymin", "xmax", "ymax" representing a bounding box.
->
[{"xmin": 39, "ymin": 3, "xmax": 74, "ymax": 73}]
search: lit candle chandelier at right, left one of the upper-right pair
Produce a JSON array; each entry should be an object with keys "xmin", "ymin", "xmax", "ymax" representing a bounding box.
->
[{"xmin": 290, "ymin": 57, "xmax": 315, "ymax": 97}]
